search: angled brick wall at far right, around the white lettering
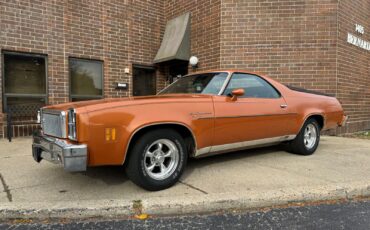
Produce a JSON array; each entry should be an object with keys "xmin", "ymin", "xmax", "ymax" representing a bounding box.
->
[{"xmin": 337, "ymin": 0, "xmax": 370, "ymax": 132}]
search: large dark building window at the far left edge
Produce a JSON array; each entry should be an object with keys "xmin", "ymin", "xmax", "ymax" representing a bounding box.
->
[{"xmin": 2, "ymin": 52, "xmax": 47, "ymax": 112}]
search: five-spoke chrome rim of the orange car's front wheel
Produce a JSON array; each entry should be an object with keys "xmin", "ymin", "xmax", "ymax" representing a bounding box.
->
[{"xmin": 144, "ymin": 139, "xmax": 180, "ymax": 180}]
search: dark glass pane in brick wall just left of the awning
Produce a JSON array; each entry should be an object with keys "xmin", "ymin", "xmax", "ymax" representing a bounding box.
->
[{"xmin": 133, "ymin": 66, "xmax": 157, "ymax": 96}]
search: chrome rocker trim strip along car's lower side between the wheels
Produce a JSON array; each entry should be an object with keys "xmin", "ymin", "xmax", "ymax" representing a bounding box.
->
[{"xmin": 194, "ymin": 135, "xmax": 296, "ymax": 157}]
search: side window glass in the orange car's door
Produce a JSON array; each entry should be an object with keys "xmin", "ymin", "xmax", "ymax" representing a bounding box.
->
[{"xmin": 224, "ymin": 73, "xmax": 280, "ymax": 98}]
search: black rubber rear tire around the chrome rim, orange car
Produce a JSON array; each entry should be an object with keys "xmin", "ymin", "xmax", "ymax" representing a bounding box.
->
[{"xmin": 289, "ymin": 118, "xmax": 320, "ymax": 156}]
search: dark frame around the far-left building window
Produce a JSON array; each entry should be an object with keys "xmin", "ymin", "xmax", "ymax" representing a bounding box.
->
[{"xmin": 1, "ymin": 50, "xmax": 49, "ymax": 113}]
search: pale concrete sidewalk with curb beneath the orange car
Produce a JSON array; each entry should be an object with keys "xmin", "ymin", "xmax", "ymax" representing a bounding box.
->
[{"xmin": 0, "ymin": 136, "xmax": 370, "ymax": 218}]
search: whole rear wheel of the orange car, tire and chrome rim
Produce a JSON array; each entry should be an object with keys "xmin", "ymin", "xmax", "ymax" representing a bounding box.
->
[{"xmin": 290, "ymin": 118, "xmax": 320, "ymax": 155}]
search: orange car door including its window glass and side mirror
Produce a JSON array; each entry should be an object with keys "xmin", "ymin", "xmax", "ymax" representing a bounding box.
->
[{"xmin": 211, "ymin": 73, "xmax": 293, "ymax": 151}]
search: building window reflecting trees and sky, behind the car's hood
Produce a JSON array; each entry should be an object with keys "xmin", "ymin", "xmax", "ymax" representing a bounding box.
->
[{"xmin": 69, "ymin": 58, "xmax": 103, "ymax": 101}]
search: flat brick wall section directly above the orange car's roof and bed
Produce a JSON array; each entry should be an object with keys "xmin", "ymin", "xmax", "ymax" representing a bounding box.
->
[{"xmin": 221, "ymin": 0, "xmax": 337, "ymax": 94}]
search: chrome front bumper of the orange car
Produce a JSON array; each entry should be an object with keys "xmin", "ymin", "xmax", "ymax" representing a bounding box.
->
[{"xmin": 32, "ymin": 132, "xmax": 87, "ymax": 172}]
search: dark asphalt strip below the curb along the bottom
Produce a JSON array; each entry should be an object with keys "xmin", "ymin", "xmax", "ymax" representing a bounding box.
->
[{"xmin": 0, "ymin": 201, "xmax": 370, "ymax": 230}]
